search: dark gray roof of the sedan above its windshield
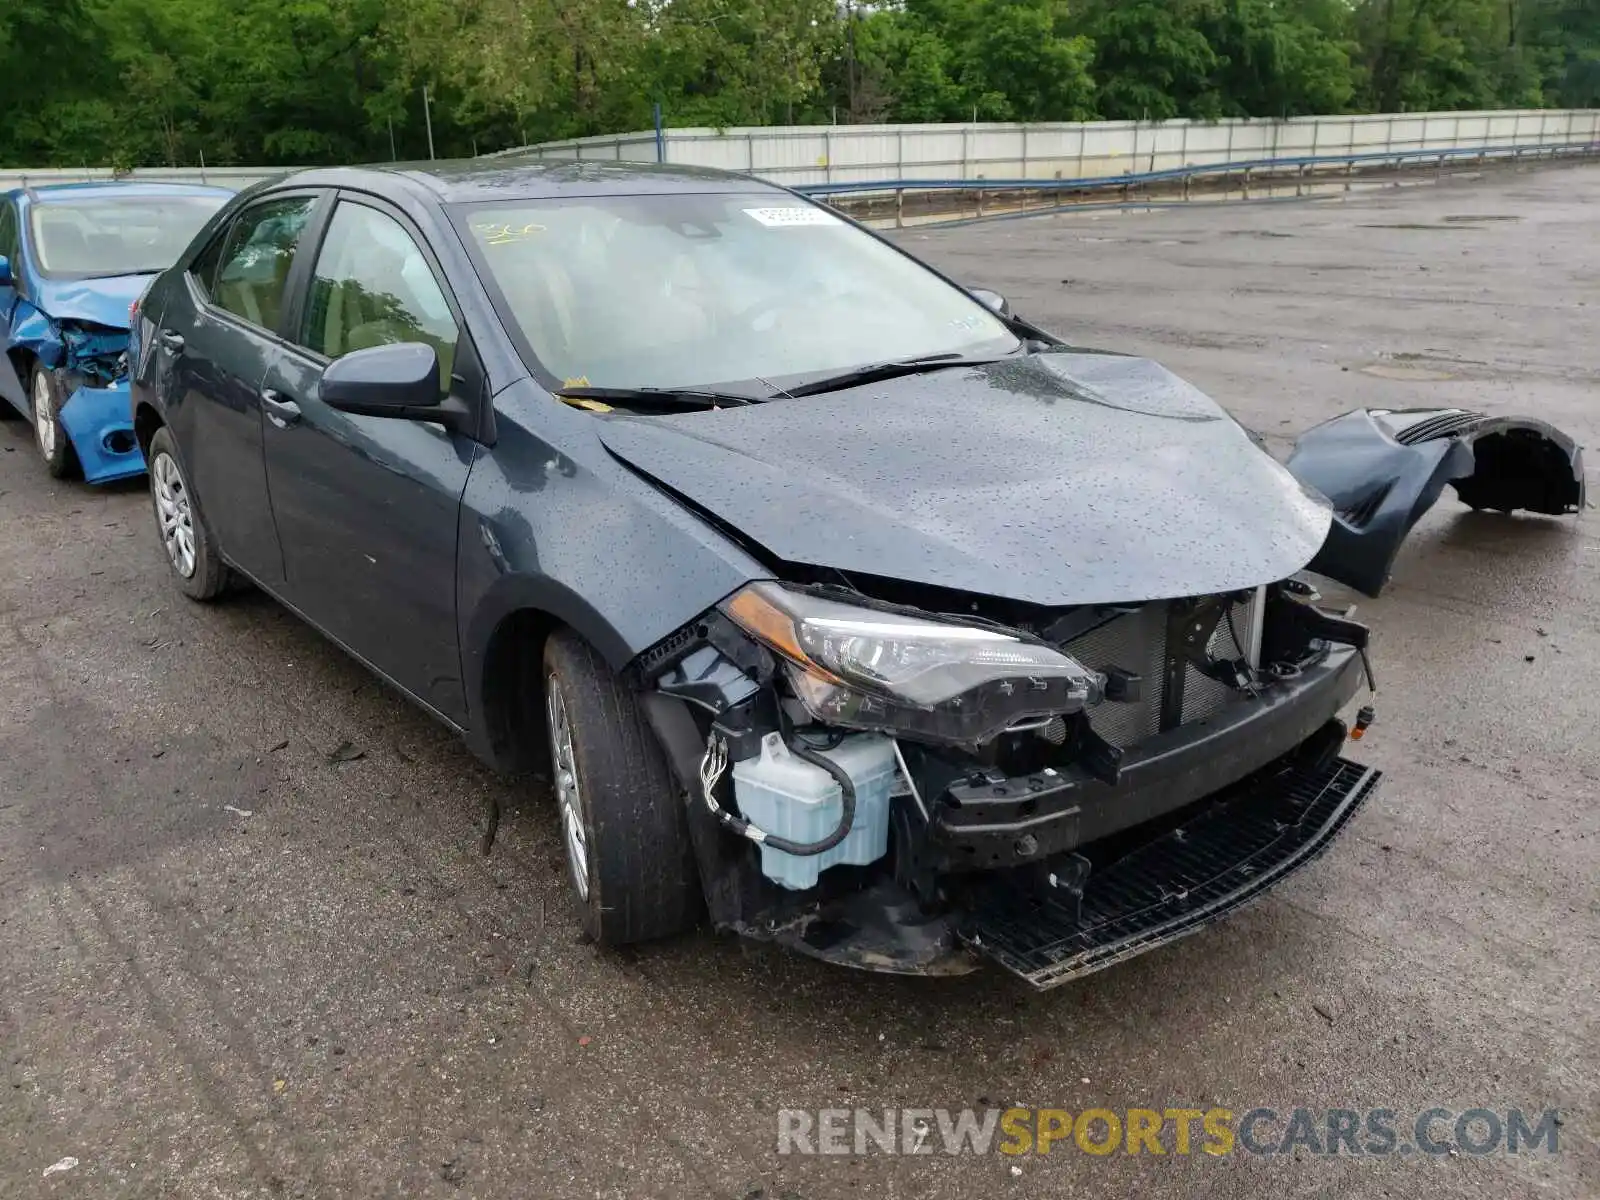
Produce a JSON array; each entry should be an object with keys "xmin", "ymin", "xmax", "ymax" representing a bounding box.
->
[{"xmin": 264, "ymin": 155, "xmax": 782, "ymax": 203}]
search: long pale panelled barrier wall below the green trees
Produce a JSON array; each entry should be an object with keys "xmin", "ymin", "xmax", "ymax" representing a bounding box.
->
[{"xmin": 0, "ymin": 109, "xmax": 1600, "ymax": 190}]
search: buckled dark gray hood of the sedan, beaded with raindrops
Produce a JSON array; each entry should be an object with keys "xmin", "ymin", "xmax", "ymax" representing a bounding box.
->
[{"xmin": 600, "ymin": 352, "xmax": 1331, "ymax": 606}]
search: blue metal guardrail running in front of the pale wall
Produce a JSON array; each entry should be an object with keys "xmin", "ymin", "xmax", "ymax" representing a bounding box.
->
[{"xmin": 794, "ymin": 141, "xmax": 1600, "ymax": 224}]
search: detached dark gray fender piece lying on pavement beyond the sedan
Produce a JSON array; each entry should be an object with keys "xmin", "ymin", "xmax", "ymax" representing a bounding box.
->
[{"xmin": 1288, "ymin": 408, "xmax": 1584, "ymax": 595}]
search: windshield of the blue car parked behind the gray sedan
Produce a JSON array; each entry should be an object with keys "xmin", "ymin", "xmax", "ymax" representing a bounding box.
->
[{"xmin": 32, "ymin": 195, "xmax": 226, "ymax": 278}]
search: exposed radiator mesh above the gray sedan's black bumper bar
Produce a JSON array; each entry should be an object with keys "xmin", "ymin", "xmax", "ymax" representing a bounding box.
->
[{"xmin": 1064, "ymin": 592, "xmax": 1259, "ymax": 746}]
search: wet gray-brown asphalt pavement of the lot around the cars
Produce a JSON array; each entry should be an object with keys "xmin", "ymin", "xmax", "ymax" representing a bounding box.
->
[{"xmin": 0, "ymin": 166, "xmax": 1600, "ymax": 1200}]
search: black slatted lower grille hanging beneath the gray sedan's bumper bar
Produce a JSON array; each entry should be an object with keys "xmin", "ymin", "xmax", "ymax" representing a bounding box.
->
[{"xmin": 963, "ymin": 758, "xmax": 1381, "ymax": 989}]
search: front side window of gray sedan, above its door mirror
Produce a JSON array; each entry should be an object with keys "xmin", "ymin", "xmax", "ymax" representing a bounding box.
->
[{"xmin": 299, "ymin": 200, "xmax": 461, "ymax": 392}]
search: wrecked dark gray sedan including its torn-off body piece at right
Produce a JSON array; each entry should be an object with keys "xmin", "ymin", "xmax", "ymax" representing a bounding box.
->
[{"xmin": 133, "ymin": 162, "xmax": 1582, "ymax": 987}]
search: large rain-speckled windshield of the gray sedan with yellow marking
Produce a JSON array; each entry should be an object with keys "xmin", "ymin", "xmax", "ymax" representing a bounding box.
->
[{"xmin": 459, "ymin": 192, "xmax": 1019, "ymax": 387}]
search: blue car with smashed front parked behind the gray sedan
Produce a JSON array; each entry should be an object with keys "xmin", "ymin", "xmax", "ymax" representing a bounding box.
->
[{"xmin": 0, "ymin": 182, "xmax": 232, "ymax": 483}]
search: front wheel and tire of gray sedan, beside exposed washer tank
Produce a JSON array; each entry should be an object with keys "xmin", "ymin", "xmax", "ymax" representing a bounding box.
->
[{"xmin": 544, "ymin": 630, "xmax": 702, "ymax": 946}]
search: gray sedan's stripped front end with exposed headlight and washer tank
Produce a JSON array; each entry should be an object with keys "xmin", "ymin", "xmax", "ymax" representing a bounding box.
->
[{"xmin": 634, "ymin": 581, "xmax": 1378, "ymax": 987}]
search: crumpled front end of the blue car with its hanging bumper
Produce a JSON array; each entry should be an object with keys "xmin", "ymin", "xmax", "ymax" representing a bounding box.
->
[{"xmin": 5, "ymin": 306, "xmax": 144, "ymax": 483}]
